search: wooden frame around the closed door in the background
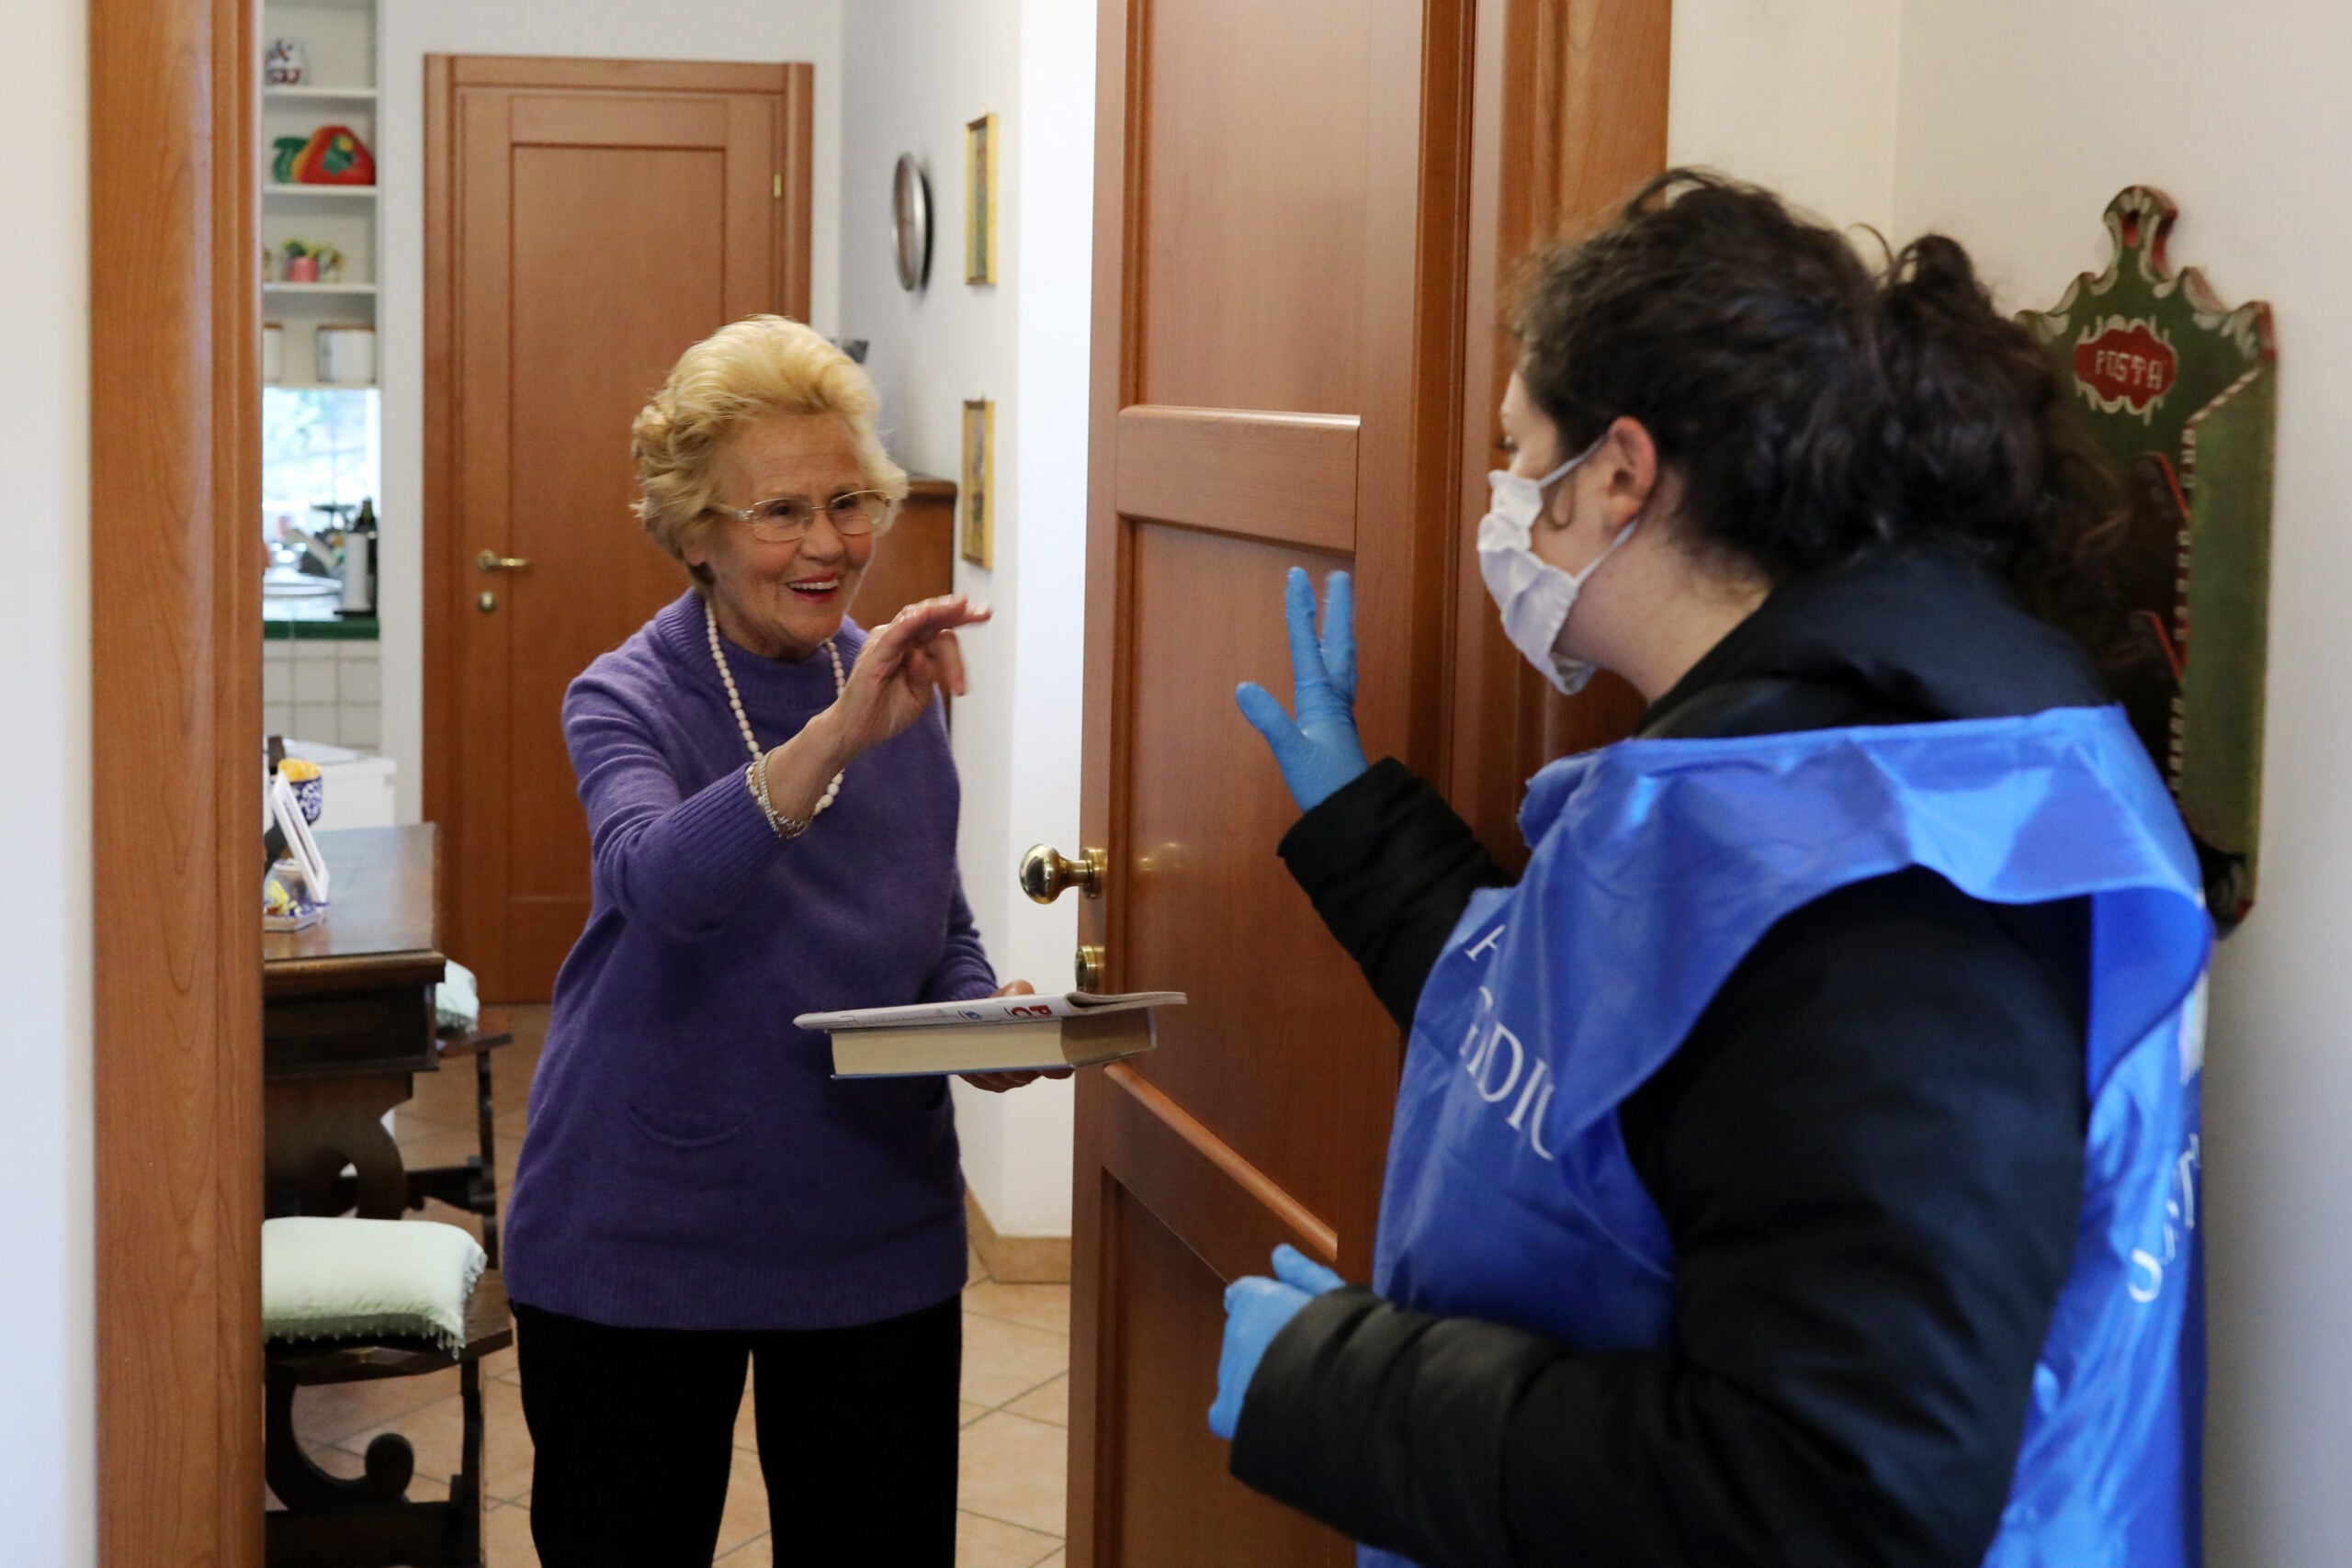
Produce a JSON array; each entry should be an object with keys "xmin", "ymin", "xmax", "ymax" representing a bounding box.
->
[{"xmin": 421, "ymin": 54, "xmax": 816, "ymax": 964}]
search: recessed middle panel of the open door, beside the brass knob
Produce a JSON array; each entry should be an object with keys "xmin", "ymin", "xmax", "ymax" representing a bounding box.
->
[{"xmin": 1120, "ymin": 525, "xmax": 1395, "ymax": 1215}]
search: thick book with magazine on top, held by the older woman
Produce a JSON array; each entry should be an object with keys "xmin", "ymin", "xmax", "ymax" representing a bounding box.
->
[{"xmin": 793, "ymin": 992, "xmax": 1183, "ymax": 1079}]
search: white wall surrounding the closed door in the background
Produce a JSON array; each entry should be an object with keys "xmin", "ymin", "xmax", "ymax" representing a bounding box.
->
[{"xmin": 377, "ymin": 0, "xmax": 844, "ymax": 820}]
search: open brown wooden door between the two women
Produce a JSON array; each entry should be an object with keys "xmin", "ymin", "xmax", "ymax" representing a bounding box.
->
[{"xmin": 1070, "ymin": 0, "xmax": 1470, "ymax": 1568}]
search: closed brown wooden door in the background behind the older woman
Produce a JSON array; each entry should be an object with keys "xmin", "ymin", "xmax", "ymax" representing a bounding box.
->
[{"xmin": 425, "ymin": 56, "xmax": 811, "ymax": 1001}]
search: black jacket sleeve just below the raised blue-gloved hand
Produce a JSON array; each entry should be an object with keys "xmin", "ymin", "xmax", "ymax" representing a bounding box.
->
[{"xmin": 1280, "ymin": 757, "xmax": 1510, "ymax": 1030}]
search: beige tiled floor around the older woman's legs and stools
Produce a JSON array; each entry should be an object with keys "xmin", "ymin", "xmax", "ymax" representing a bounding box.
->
[{"xmin": 277, "ymin": 1009, "xmax": 1070, "ymax": 1568}]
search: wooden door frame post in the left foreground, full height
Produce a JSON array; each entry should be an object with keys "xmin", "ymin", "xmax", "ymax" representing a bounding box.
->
[{"xmin": 91, "ymin": 0, "xmax": 261, "ymax": 1568}]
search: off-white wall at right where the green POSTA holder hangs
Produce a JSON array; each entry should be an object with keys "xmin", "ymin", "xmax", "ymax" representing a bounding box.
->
[{"xmin": 1895, "ymin": 0, "xmax": 2352, "ymax": 1568}]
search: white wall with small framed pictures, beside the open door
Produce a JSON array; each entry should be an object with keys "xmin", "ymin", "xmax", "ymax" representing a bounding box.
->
[{"xmin": 840, "ymin": 0, "xmax": 1093, "ymax": 1236}]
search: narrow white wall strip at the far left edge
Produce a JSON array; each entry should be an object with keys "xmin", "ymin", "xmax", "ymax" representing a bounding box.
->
[{"xmin": 0, "ymin": 0, "xmax": 94, "ymax": 1568}]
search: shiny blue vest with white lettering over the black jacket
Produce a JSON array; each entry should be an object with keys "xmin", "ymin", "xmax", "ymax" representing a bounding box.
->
[{"xmin": 1364, "ymin": 707, "xmax": 2213, "ymax": 1568}]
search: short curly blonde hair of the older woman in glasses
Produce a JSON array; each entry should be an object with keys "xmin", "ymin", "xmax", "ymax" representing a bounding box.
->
[{"xmin": 628, "ymin": 315, "xmax": 906, "ymax": 562}]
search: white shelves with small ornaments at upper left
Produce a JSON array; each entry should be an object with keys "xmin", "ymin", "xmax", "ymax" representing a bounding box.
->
[{"xmin": 254, "ymin": 0, "xmax": 381, "ymax": 388}]
